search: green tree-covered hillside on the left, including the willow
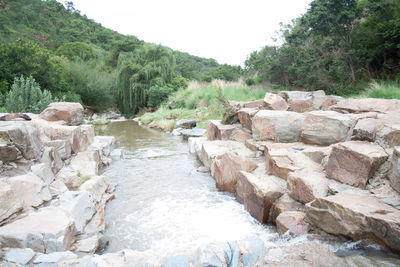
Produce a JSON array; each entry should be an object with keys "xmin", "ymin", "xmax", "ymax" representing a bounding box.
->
[{"xmin": 0, "ymin": 0, "xmax": 243, "ymax": 115}]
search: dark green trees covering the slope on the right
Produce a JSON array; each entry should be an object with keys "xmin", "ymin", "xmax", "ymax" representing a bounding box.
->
[{"xmin": 245, "ymin": 0, "xmax": 400, "ymax": 95}]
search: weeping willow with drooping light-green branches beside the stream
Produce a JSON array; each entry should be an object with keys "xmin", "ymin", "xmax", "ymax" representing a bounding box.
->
[{"xmin": 116, "ymin": 45, "xmax": 175, "ymax": 115}]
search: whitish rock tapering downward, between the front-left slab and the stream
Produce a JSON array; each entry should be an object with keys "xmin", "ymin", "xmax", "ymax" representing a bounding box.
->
[{"xmin": 53, "ymin": 191, "xmax": 95, "ymax": 234}]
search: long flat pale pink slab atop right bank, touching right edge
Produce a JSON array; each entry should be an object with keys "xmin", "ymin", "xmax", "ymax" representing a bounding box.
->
[{"xmin": 330, "ymin": 98, "xmax": 400, "ymax": 113}]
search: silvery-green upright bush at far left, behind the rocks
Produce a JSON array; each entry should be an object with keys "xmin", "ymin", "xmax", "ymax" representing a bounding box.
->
[{"xmin": 5, "ymin": 75, "xmax": 53, "ymax": 113}]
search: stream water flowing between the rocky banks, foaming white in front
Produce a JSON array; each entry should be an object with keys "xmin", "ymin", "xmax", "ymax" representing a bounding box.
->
[{"xmin": 96, "ymin": 121, "xmax": 400, "ymax": 265}]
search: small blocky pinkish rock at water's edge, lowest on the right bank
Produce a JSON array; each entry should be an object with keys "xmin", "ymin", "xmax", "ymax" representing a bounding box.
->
[{"xmin": 276, "ymin": 211, "xmax": 310, "ymax": 235}]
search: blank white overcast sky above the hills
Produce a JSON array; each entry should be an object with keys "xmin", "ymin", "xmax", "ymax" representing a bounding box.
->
[{"xmin": 60, "ymin": 0, "xmax": 311, "ymax": 66}]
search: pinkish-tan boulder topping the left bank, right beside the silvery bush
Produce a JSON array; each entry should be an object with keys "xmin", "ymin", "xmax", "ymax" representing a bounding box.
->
[{"xmin": 40, "ymin": 102, "xmax": 83, "ymax": 125}]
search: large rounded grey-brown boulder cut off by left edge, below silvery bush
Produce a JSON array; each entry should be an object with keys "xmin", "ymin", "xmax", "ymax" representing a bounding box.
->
[{"xmin": 0, "ymin": 122, "xmax": 43, "ymax": 162}]
